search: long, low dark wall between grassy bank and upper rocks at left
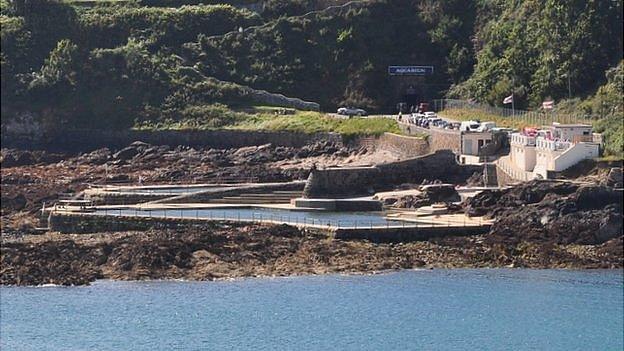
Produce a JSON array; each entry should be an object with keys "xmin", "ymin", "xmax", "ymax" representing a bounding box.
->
[{"xmin": 2, "ymin": 130, "xmax": 342, "ymax": 152}]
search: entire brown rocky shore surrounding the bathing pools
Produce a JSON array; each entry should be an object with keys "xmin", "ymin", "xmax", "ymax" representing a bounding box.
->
[{"xmin": 0, "ymin": 142, "xmax": 624, "ymax": 285}]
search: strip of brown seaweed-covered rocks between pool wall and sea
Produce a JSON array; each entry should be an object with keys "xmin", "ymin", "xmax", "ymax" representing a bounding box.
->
[{"xmin": 0, "ymin": 223, "xmax": 623, "ymax": 285}]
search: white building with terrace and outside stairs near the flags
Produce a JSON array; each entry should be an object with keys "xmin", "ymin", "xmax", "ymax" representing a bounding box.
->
[{"xmin": 509, "ymin": 123, "xmax": 600, "ymax": 179}]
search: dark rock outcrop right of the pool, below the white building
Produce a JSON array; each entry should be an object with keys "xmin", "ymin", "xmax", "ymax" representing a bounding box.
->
[{"xmin": 465, "ymin": 181, "xmax": 624, "ymax": 244}]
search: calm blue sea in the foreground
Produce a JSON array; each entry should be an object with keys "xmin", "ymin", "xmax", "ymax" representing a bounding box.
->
[{"xmin": 0, "ymin": 269, "xmax": 624, "ymax": 351}]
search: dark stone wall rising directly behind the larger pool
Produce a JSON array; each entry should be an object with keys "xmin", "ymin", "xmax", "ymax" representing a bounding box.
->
[{"xmin": 303, "ymin": 150, "xmax": 483, "ymax": 198}]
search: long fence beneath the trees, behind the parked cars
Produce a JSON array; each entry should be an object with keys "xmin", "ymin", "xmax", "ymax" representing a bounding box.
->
[{"xmin": 433, "ymin": 99, "xmax": 601, "ymax": 125}]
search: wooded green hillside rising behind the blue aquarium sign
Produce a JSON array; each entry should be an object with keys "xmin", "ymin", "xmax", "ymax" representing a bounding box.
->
[{"xmin": 0, "ymin": 0, "xmax": 622, "ymax": 146}]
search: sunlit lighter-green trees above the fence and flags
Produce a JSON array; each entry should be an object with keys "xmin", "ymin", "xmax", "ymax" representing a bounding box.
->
[{"xmin": 452, "ymin": 0, "xmax": 622, "ymax": 108}]
